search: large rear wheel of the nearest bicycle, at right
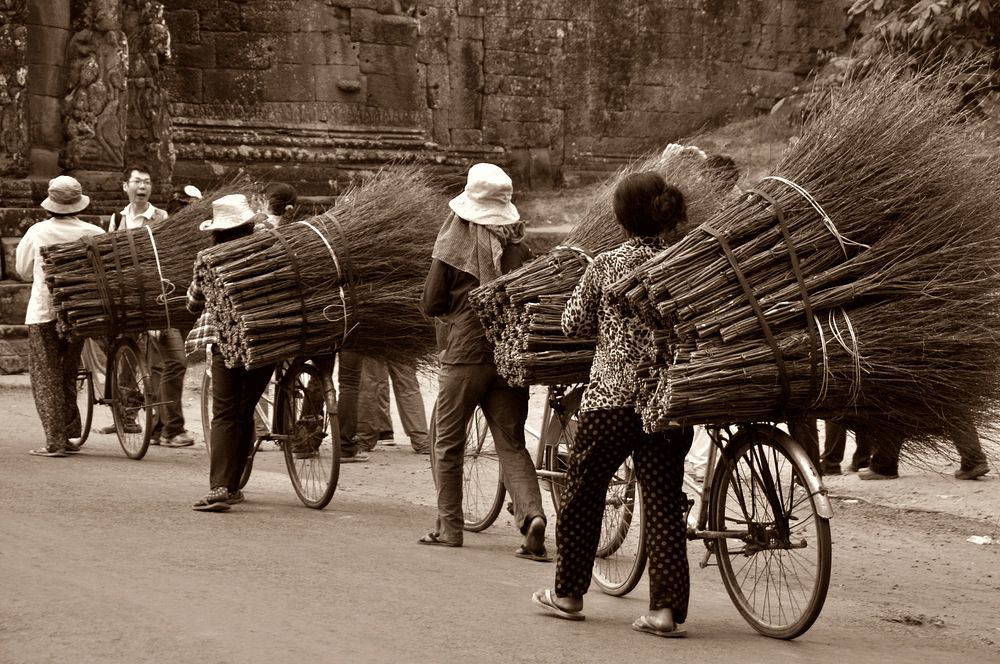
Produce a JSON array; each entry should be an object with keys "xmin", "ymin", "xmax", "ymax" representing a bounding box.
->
[{"xmin": 708, "ymin": 426, "xmax": 831, "ymax": 639}]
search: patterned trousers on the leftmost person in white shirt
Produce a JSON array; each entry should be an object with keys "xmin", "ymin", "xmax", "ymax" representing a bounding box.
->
[{"xmin": 28, "ymin": 321, "xmax": 83, "ymax": 449}]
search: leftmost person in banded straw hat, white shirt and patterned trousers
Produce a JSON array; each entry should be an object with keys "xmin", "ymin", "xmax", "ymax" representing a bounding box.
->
[{"xmin": 16, "ymin": 175, "xmax": 104, "ymax": 457}]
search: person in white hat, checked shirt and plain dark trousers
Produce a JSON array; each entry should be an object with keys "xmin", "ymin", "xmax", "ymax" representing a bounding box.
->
[{"xmin": 185, "ymin": 194, "xmax": 274, "ymax": 512}]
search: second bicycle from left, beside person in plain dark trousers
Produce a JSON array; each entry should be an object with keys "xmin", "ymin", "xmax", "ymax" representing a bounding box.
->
[{"xmin": 201, "ymin": 350, "xmax": 340, "ymax": 509}]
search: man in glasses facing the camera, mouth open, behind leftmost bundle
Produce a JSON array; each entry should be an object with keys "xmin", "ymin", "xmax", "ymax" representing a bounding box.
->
[{"xmin": 100, "ymin": 164, "xmax": 194, "ymax": 447}]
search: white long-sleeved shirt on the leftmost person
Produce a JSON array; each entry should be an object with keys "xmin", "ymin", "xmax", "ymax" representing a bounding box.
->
[{"xmin": 15, "ymin": 217, "xmax": 104, "ymax": 325}]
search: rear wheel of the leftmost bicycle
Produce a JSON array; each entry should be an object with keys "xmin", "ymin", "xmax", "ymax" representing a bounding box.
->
[{"xmin": 111, "ymin": 337, "xmax": 153, "ymax": 459}]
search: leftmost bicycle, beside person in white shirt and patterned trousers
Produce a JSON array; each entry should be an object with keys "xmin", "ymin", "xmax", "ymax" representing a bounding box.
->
[{"xmin": 76, "ymin": 331, "xmax": 172, "ymax": 460}]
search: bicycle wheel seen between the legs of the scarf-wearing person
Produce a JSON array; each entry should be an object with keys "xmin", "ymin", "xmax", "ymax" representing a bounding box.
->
[{"xmin": 462, "ymin": 406, "xmax": 507, "ymax": 533}]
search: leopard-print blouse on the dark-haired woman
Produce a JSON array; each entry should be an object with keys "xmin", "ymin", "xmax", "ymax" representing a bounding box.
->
[{"xmin": 562, "ymin": 237, "xmax": 666, "ymax": 410}]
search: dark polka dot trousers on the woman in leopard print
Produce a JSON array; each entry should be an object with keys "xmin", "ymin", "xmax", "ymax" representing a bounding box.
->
[{"xmin": 556, "ymin": 408, "xmax": 694, "ymax": 623}]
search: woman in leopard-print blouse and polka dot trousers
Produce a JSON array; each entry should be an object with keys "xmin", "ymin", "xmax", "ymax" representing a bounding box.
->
[{"xmin": 532, "ymin": 171, "xmax": 694, "ymax": 637}]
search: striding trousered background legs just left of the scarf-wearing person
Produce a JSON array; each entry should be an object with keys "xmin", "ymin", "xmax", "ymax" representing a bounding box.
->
[{"xmin": 355, "ymin": 357, "xmax": 430, "ymax": 454}]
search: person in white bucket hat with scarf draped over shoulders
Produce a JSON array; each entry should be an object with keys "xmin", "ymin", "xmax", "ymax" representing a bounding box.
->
[{"xmin": 419, "ymin": 164, "xmax": 549, "ymax": 561}]
